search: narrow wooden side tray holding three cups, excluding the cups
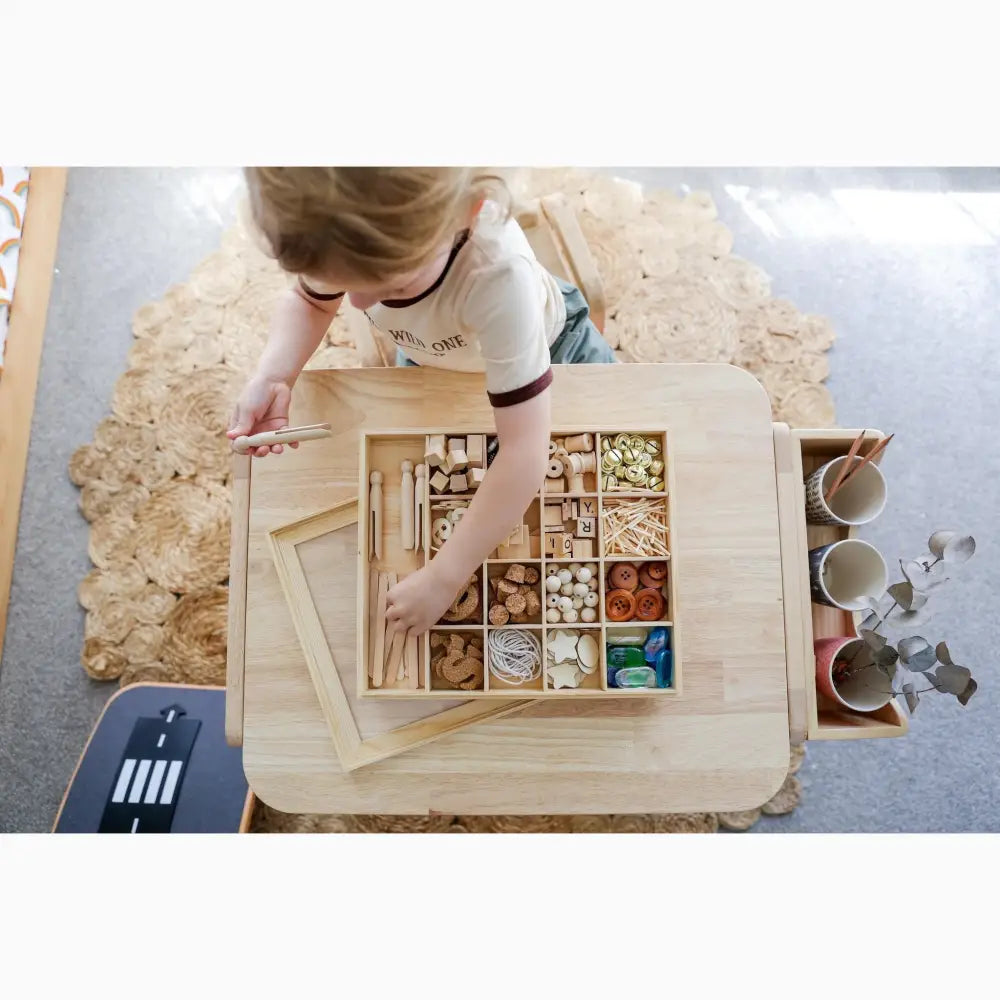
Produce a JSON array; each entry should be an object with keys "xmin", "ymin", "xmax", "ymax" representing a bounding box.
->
[{"xmin": 774, "ymin": 424, "xmax": 909, "ymax": 742}]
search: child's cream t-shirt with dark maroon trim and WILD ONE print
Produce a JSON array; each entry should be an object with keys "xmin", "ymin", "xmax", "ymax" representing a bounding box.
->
[{"xmin": 303, "ymin": 206, "xmax": 566, "ymax": 407}]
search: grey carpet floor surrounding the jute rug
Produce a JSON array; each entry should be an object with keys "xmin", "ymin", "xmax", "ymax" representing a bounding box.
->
[{"xmin": 0, "ymin": 168, "xmax": 1000, "ymax": 832}]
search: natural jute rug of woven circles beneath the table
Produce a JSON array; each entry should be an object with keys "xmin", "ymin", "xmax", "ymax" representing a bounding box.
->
[{"xmin": 69, "ymin": 170, "xmax": 834, "ymax": 832}]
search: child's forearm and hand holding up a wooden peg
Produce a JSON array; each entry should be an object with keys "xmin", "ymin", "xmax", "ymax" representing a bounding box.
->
[{"xmin": 228, "ymin": 285, "xmax": 341, "ymax": 458}]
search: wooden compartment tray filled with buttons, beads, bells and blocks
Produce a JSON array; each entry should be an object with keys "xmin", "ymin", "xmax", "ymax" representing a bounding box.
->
[{"xmin": 358, "ymin": 427, "xmax": 681, "ymax": 699}]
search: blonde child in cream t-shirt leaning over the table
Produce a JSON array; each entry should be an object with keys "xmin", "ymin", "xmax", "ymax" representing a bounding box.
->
[{"xmin": 228, "ymin": 167, "xmax": 615, "ymax": 635}]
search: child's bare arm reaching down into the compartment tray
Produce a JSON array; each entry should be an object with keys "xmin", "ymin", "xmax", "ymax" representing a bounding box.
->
[{"xmin": 386, "ymin": 389, "xmax": 551, "ymax": 635}]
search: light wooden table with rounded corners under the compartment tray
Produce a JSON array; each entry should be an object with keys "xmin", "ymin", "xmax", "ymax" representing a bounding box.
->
[{"xmin": 230, "ymin": 365, "xmax": 789, "ymax": 815}]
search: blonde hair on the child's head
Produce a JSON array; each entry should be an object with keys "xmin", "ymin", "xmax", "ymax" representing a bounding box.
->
[{"xmin": 245, "ymin": 167, "xmax": 511, "ymax": 281}]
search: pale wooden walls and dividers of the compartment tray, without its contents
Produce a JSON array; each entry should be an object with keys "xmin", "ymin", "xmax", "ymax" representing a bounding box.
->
[{"xmin": 358, "ymin": 427, "xmax": 681, "ymax": 700}]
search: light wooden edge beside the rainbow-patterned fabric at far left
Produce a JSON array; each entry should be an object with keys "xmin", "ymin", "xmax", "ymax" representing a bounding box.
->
[{"xmin": 0, "ymin": 167, "xmax": 66, "ymax": 656}]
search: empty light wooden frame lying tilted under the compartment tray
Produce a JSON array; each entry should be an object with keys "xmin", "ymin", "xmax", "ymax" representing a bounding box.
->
[{"xmin": 268, "ymin": 498, "xmax": 525, "ymax": 771}]
